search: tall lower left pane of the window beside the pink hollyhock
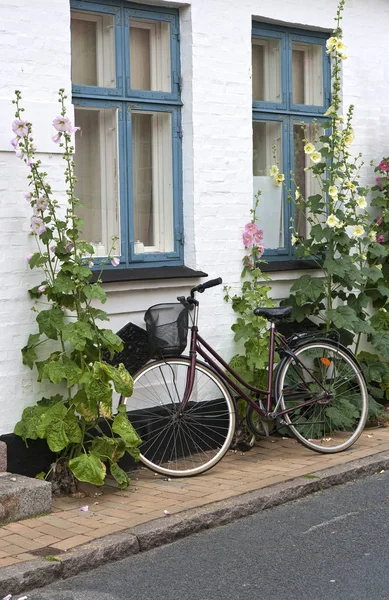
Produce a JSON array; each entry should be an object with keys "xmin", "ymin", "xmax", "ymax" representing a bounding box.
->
[{"xmin": 75, "ymin": 107, "xmax": 120, "ymax": 256}]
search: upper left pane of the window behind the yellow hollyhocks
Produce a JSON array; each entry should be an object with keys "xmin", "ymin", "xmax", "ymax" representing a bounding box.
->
[{"xmin": 252, "ymin": 38, "xmax": 281, "ymax": 102}]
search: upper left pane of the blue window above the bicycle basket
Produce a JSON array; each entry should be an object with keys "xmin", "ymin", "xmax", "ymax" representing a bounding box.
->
[{"xmin": 71, "ymin": 11, "xmax": 116, "ymax": 87}]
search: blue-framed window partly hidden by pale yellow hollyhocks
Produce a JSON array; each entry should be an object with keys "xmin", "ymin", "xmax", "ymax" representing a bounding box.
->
[{"xmin": 252, "ymin": 23, "xmax": 331, "ymax": 261}]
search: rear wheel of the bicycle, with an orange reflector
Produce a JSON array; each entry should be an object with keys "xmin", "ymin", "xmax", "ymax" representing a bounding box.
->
[{"xmin": 275, "ymin": 341, "xmax": 368, "ymax": 453}]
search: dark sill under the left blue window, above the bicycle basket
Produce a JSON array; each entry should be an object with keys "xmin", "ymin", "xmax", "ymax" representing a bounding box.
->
[{"xmin": 91, "ymin": 266, "xmax": 208, "ymax": 283}]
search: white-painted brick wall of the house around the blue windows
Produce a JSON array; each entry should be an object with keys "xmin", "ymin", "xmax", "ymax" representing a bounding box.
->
[{"xmin": 0, "ymin": 0, "xmax": 389, "ymax": 434}]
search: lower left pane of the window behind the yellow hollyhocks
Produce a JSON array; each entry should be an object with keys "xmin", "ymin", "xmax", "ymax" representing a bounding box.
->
[{"xmin": 253, "ymin": 121, "xmax": 284, "ymax": 248}]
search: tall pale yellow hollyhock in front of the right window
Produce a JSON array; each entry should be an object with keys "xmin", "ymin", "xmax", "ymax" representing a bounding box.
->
[{"xmin": 284, "ymin": 0, "xmax": 389, "ymax": 352}]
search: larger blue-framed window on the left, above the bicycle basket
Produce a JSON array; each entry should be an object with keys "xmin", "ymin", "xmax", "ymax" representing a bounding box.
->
[{"xmin": 71, "ymin": 0, "xmax": 183, "ymax": 267}]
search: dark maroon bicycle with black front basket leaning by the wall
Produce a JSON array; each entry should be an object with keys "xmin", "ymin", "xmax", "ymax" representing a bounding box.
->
[{"xmin": 120, "ymin": 278, "xmax": 368, "ymax": 477}]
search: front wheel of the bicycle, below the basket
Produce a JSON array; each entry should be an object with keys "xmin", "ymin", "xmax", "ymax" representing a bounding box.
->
[{"xmin": 121, "ymin": 358, "xmax": 235, "ymax": 477}]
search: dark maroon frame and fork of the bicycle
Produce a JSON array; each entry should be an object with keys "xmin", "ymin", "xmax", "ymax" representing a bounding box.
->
[{"xmin": 182, "ymin": 301, "xmax": 325, "ymax": 420}]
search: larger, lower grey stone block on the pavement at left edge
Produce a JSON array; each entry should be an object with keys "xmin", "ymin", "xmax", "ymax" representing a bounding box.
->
[{"xmin": 0, "ymin": 473, "xmax": 51, "ymax": 524}]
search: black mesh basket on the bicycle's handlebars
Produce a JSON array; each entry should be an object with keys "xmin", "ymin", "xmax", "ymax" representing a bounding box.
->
[{"xmin": 144, "ymin": 303, "xmax": 188, "ymax": 358}]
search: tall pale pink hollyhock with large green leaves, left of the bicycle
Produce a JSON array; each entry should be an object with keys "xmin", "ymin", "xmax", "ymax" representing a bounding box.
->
[{"xmin": 14, "ymin": 90, "xmax": 141, "ymax": 488}]
